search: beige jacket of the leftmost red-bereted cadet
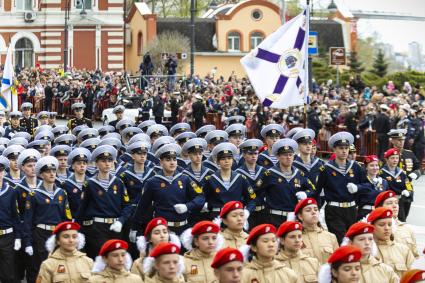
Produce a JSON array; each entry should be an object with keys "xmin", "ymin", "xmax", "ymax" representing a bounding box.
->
[{"xmin": 37, "ymin": 249, "xmax": 93, "ymax": 283}]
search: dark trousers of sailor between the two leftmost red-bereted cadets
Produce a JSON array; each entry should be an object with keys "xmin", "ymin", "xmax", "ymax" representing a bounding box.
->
[{"xmin": 81, "ymin": 222, "xmax": 122, "ymax": 259}]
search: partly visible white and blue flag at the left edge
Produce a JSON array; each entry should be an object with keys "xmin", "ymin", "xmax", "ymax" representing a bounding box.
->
[{"xmin": 0, "ymin": 46, "xmax": 18, "ymax": 111}]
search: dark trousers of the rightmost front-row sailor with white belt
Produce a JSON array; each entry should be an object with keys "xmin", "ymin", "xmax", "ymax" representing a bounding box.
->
[{"xmin": 325, "ymin": 204, "xmax": 357, "ymax": 243}]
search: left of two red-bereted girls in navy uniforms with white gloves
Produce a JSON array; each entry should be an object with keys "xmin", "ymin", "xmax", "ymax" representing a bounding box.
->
[{"xmin": 347, "ymin": 155, "xmax": 388, "ymax": 220}]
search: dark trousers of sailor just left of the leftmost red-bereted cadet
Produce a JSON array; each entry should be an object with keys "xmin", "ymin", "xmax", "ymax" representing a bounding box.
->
[{"xmin": 27, "ymin": 227, "xmax": 52, "ymax": 283}]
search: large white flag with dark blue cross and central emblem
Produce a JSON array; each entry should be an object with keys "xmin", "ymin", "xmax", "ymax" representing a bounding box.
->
[{"xmin": 241, "ymin": 7, "xmax": 309, "ymax": 109}]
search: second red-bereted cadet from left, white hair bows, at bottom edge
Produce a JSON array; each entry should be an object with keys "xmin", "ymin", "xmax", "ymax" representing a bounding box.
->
[{"xmin": 89, "ymin": 239, "xmax": 143, "ymax": 283}]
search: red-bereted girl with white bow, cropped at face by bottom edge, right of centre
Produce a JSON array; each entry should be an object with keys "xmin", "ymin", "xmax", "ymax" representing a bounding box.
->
[{"xmin": 319, "ymin": 246, "xmax": 362, "ymax": 283}]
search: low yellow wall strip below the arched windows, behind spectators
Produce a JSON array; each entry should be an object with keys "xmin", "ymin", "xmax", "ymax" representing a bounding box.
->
[{"xmin": 186, "ymin": 55, "xmax": 246, "ymax": 80}]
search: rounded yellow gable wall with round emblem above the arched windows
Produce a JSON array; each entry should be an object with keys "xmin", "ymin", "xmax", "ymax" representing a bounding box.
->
[{"xmin": 216, "ymin": 5, "xmax": 281, "ymax": 52}]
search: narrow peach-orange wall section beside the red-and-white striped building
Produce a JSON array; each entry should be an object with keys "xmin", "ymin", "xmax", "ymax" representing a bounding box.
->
[{"xmin": 125, "ymin": 11, "xmax": 148, "ymax": 74}]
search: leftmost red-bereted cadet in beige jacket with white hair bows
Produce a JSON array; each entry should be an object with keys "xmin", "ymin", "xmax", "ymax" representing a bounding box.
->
[{"xmin": 37, "ymin": 221, "xmax": 93, "ymax": 283}]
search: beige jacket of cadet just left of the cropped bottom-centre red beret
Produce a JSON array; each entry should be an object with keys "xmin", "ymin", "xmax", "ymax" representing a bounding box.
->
[{"xmin": 183, "ymin": 249, "xmax": 215, "ymax": 283}]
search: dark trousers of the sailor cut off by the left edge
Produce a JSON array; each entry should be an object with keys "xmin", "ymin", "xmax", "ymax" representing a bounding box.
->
[{"xmin": 0, "ymin": 233, "xmax": 15, "ymax": 283}]
